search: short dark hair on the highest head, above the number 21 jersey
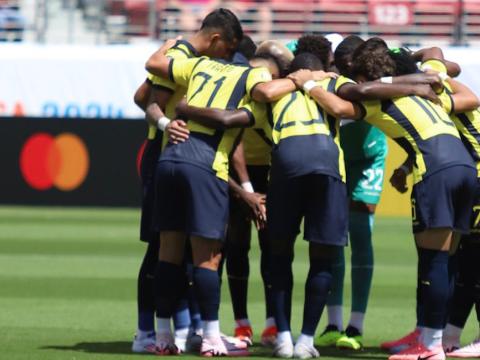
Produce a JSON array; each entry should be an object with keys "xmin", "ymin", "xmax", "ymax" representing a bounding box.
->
[{"xmin": 200, "ymin": 8, "xmax": 243, "ymax": 41}]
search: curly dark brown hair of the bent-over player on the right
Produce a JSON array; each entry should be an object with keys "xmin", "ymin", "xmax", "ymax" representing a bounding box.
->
[{"xmin": 352, "ymin": 37, "xmax": 396, "ymax": 81}]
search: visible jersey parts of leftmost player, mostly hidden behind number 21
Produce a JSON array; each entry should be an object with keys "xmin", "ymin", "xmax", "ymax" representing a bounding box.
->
[{"xmin": 147, "ymin": 40, "xmax": 198, "ymax": 140}]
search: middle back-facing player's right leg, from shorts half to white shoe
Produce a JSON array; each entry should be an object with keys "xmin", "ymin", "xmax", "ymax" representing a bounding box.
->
[{"xmin": 294, "ymin": 175, "xmax": 348, "ymax": 358}]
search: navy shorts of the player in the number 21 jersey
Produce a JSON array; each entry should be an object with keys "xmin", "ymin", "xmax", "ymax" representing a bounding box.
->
[{"xmin": 154, "ymin": 161, "xmax": 228, "ymax": 240}]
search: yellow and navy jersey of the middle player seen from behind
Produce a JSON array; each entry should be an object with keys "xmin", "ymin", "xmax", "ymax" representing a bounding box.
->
[{"xmin": 270, "ymin": 79, "xmax": 345, "ymax": 181}]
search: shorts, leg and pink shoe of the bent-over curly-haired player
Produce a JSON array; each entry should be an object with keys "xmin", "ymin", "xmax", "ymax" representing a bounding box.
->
[{"xmin": 391, "ymin": 167, "xmax": 476, "ymax": 360}]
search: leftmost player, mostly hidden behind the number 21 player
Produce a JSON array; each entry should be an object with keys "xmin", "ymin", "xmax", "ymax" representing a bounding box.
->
[{"xmin": 132, "ymin": 9, "xmax": 248, "ymax": 352}]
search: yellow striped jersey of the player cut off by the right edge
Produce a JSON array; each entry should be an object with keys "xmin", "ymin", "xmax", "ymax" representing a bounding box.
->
[{"xmin": 422, "ymin": 60, "xmax": 480, "ymax": 177}]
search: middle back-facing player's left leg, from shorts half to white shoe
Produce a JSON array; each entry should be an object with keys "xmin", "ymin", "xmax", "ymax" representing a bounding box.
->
[{"xmin": 267, "ymin": 176, "xmax": 303, "ymax": 357}]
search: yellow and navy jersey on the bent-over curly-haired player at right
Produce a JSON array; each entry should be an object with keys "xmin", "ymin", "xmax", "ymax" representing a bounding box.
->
[{"xmin": 362, "ymin": 91, "xmax": 474, "ymax": 184}]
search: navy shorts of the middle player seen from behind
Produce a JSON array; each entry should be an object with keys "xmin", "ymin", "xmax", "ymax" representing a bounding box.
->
[{"xmin": 267, "ymin": 174, "xmax": 348, "ymax": 246}]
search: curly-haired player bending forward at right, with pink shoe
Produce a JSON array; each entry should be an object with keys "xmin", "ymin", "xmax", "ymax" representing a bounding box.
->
[{"xmin": 294, "ymin": 38, "xmax": 476, "ymax": 360}]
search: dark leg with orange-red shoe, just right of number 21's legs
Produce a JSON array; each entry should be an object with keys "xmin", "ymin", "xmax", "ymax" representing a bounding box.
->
[{"xmin": 225, "ymin": 199, "xmax": 253, "ymax": 345}]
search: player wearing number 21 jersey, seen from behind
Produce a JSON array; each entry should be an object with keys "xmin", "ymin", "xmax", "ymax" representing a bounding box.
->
[{"xmin": 142, "ymin": 24, "xmax": 294, "ymax": 356}]
